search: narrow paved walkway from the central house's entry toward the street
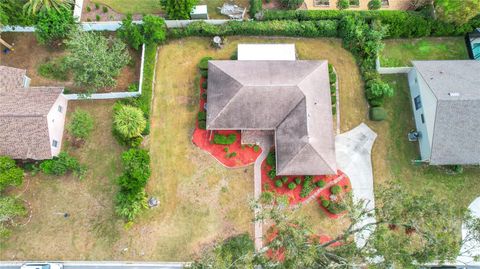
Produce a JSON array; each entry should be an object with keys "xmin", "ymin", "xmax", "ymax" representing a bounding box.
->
[{"xmin": 253, "ymin": 134, "xmax": 273, "ymax": 251}]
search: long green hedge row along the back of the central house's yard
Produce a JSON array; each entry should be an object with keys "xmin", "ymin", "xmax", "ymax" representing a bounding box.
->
[{"xmin": 169, "ymin": 20, "xmax": 338, "ymax": 38}]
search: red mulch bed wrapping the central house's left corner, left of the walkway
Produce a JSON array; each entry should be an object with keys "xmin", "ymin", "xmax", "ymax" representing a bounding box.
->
[{"xmin": 192, "ymin": 78, "xmax": 262, "ymax": 167}]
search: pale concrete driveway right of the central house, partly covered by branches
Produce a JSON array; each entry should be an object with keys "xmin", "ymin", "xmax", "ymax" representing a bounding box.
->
[{"xmin": 335, "ymin": 123, "xmax": 377, "ymax": 247}]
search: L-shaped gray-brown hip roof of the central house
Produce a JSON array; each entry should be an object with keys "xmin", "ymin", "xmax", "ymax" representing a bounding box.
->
[{"xmin": 207, "ymin": 60, "xmax": 337, "ymax": 175}]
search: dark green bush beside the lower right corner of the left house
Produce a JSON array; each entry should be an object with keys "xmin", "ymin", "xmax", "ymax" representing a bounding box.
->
[{"xmin": 40, "ymin": 152, "xmax": 86, "ymax": 178}]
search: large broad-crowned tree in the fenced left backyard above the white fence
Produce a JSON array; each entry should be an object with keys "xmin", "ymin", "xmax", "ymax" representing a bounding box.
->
[{"xmin": 66, "ymin": 31, "xmax": 130, "ymax": 91}]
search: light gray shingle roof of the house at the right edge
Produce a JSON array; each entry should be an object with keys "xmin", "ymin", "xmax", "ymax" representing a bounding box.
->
[{"xmin": 413, "ymin": 60, "xmax": 480, "ymax": 165}]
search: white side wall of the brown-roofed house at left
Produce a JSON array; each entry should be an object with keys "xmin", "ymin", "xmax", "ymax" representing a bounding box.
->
[{"xmin": 47, "ymin": 94, "xmax": 68, "ymax": 156}]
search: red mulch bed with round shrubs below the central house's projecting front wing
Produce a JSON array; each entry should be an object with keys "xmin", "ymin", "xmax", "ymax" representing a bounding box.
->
[{"xmin": 262, "ymin": 155, "xmax": 350, "ymax": 205}]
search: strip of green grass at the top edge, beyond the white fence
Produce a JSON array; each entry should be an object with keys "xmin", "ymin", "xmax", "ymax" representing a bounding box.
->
[{"xmin": 93, "ymin": 0, "xmax": 162, "ymax": 14}]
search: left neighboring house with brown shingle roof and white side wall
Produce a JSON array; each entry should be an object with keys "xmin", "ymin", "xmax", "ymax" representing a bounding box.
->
[{"xmin": 0, "ymin": 66, "xmax": 68, "ymax": 160}]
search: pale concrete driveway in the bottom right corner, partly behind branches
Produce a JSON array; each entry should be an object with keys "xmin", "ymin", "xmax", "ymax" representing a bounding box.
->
[{"xmin": 457, "ymin": 197, "xmax": 480, "ymax": 266}]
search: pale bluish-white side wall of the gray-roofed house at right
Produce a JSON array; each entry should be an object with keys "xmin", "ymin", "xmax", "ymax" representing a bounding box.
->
[{"xmin": 408, "ymin": 69, "xmax": 437, "ymax": 161}]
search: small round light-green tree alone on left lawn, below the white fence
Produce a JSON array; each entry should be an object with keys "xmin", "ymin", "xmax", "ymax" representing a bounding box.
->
[{"xmin": 113, "ymin": 105, "xmax": 147, "ymax": 139}]
